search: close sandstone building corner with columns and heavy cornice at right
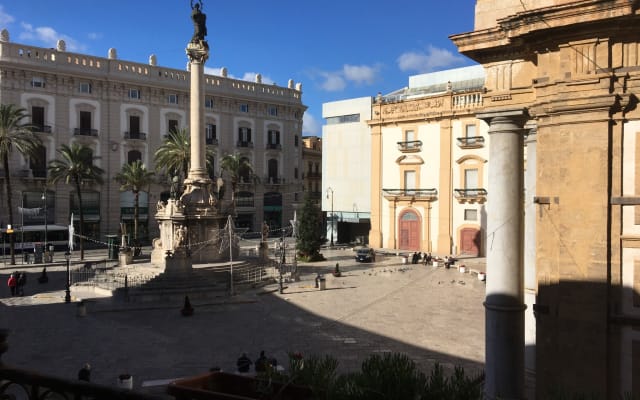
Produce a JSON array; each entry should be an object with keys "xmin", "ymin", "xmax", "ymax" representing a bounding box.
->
[{"xmin": 451, "ymin": 0, "xmax": 640, "ymax": 399}]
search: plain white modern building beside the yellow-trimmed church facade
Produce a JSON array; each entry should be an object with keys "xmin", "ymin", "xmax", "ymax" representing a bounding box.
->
[{"xmin": 322, "ymin": 97, "xmax": 372, "ymax": 245}]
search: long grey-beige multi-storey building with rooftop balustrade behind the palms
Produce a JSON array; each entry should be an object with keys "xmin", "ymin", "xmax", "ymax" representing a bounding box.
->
[{"xmin": 0, "ymin": 30, "xmax": 306, "ymax": 247}]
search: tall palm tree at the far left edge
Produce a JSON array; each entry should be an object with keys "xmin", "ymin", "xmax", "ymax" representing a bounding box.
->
[{"xmin": 0, "ymin": 104, "xmax": 42, "ymax": 265}]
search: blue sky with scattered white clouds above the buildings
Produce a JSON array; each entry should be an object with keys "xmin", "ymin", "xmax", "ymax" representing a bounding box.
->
[{"xmin": 0, "ymin": 0, "xmax": 475, "ymax": 135}]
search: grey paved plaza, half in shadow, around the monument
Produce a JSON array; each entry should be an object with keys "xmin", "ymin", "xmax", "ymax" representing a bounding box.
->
[{"xmin": 0, "ymin": 249, "xmax": 485, "ymax": 391}]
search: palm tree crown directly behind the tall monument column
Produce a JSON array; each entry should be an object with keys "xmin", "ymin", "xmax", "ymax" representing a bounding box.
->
[{"xmin": 153, "ymin": 129, "xmax": 215, "ymax": 197}]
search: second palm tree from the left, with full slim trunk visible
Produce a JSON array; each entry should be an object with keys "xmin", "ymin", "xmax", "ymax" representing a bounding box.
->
[{"xmin": 48, "ymin": 143, "xmax": 104, "ymax": 260}]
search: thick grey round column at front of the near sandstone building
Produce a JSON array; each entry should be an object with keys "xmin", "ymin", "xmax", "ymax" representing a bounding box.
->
[{"xmin": 477, "ymin": 109, "xmax": 528, "ymax": 400}]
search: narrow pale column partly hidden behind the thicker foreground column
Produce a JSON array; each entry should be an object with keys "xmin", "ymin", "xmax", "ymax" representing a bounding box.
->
[{"xmin": 524, "ymin": 125, "xmax": 538, "ymax": 399}]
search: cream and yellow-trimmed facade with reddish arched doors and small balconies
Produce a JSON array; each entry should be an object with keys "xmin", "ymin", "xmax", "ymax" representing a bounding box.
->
[{"xmin": 367, "ymin": 66, "xmax": 489, "ymax": 256}]
